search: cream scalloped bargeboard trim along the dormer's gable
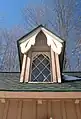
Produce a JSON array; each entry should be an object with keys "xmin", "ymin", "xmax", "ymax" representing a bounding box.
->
[{"xmin": 20, "ymin": 26, "xmax": 63, "ymax": 54}]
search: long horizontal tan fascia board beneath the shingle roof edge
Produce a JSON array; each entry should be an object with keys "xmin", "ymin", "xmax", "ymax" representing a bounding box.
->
[{"xmin": 0, "ymin": 91, "xmax": 81, "ymax": 100}]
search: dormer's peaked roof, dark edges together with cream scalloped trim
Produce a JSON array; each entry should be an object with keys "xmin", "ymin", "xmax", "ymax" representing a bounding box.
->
[{"xmin": 17, "ymin": 25, "xmax": 65, "ymax": 69}]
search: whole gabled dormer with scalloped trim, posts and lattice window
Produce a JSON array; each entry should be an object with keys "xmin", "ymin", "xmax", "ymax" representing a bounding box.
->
[{"xmin": 17, "ymin": 25, "xmax": 64, "ymax": 83}]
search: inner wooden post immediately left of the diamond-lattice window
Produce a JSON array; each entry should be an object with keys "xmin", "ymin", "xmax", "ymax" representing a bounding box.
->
[{"xmin": 25, "ymin": 51, "xmax": 31, "ymax": 82}]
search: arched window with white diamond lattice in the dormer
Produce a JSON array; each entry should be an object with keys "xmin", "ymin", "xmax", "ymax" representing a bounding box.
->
[{"xmin": 31, "ymin": 54, "xmax": 51, "ymax": 82}]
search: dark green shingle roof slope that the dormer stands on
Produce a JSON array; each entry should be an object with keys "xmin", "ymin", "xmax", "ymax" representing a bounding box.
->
[{"xmin": 0, "ymin": 73, "xmax": 81, "ymax": 92}]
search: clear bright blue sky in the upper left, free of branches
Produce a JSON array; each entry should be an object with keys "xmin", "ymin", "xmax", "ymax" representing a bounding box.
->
[{"xmin": 0, "ymin": 0, "xmax": 40, "ymax": 28}]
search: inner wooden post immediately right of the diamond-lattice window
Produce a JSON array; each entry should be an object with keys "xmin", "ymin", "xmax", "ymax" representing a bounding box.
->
[{"xmin": 51, "ymin": 48, "xmax": 57, "ymax": 82}]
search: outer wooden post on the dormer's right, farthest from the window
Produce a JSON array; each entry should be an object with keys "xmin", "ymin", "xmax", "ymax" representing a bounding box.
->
[{"xmin": 55, "ymin": 54, "xmax": 61, "ymax": 83}]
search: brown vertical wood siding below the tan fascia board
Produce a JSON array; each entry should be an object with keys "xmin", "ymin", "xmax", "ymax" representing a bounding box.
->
[{"xmin": 0, "ymin": 99, "xmax": 81, "ymax": 119}]
